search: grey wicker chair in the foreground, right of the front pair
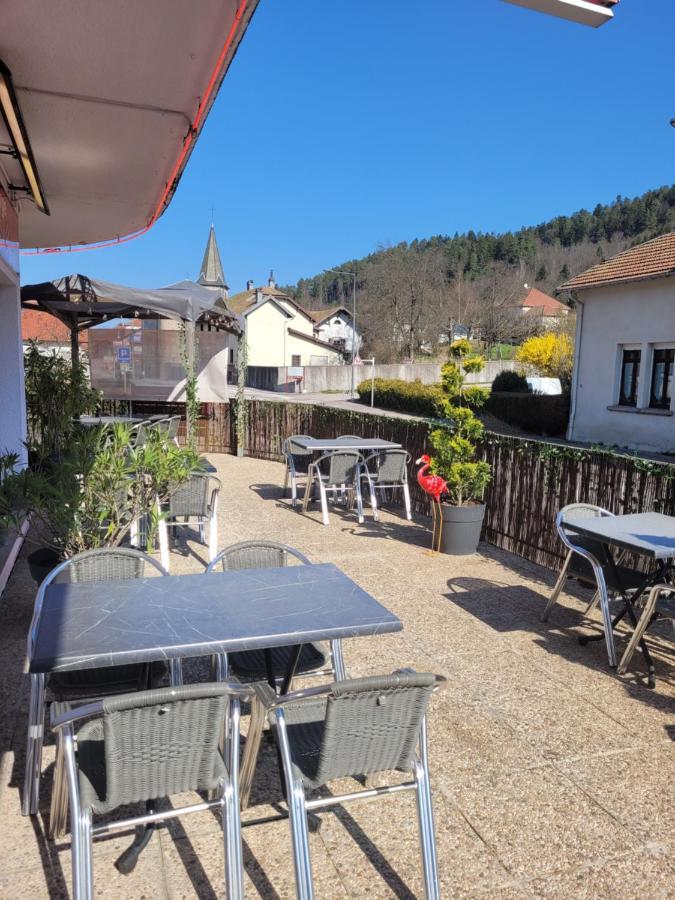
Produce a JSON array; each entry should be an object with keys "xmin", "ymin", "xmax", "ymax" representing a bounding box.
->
[{"xmin": 251, "ymin": 671, "xmax": 445, "ymax": 900}]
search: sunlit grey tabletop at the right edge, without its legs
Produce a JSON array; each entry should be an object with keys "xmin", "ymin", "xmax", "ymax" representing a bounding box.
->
[{"xmin": 565, "ymin": 513, "xmax": 675, "ymax": 560}]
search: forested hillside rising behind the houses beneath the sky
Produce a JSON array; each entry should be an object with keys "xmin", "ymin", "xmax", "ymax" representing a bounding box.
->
[{"xmin": 286, "ymin": 186, "xmax": 675, "ymax": 362}]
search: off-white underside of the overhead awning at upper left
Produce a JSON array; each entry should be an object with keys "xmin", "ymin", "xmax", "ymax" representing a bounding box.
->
[{"xmin": 0, "ymin": 0, "xmax": 258, "ymax": 247}]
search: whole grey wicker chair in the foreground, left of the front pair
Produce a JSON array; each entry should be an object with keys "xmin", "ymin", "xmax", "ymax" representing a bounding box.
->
[{"xmin": 52, "ymin": 684, "xmax": 250, "ymax": 900}]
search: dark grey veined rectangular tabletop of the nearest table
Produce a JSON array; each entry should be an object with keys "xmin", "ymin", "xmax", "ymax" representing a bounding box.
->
[{"xmin": 30, "ymin": 563, "xmax": 403, "ymax": 672}]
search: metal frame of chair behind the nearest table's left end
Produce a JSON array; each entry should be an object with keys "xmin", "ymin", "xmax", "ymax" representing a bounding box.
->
[{"xmin": 21, "ymin": 547, "xmax": 174, "ymax": 816}]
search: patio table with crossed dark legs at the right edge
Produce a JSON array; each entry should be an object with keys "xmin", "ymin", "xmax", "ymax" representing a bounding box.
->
[{"xmin": 565, "ymin": 512, "xmax": 675, "ymax": 687}]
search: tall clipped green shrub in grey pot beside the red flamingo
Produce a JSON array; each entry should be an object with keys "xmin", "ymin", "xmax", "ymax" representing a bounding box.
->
[{"xmin": 429, "ymin": 340, "xmax": 491, "ymax": 555}]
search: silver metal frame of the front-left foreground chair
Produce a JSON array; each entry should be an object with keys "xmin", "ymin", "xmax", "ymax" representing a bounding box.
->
[{"xmin": 50, "ymin": 682, "xmax": 251, "ymax": 900}]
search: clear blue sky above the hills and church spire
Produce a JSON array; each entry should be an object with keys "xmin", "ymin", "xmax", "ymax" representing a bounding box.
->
[{"xmin": 21, "ymin": 0, "xmax": 675, "ymax": 292}]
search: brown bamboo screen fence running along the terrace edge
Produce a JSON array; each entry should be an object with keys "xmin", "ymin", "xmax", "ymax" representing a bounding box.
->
[{"xmin": 101, "ymin": 400, "xmax": 675, "ymax": 569}]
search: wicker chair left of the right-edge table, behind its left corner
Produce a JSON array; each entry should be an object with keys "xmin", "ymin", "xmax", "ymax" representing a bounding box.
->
[{"xmin": 542, "ymin": 503, "xmax": 643, "ymax": 666}]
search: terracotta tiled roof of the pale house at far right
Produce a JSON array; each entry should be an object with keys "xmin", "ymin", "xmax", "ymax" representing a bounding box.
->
[{"xmin": 558, "ymin": 231, "xmax": 675, "ymax": 291}]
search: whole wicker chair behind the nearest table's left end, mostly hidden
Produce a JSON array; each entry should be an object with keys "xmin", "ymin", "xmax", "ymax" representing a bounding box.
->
[{"xmin": 22, "ymin": 547, "xmax": 173, "ymax": 815}]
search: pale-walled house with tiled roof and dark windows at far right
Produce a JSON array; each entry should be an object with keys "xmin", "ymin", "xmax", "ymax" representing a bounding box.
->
[{"xmin": 558, "ymin": 232, "xmax": 675, "ymax": 453}]
